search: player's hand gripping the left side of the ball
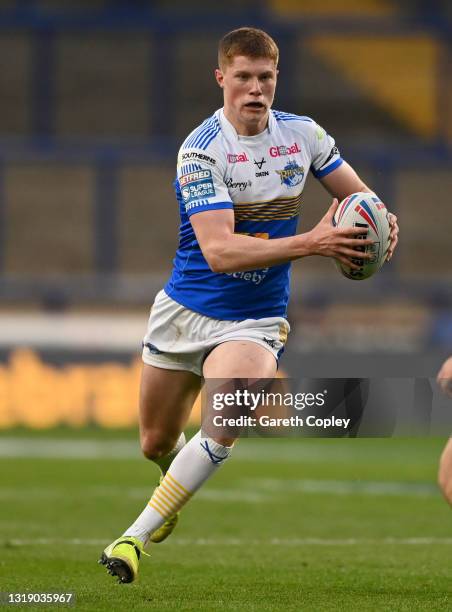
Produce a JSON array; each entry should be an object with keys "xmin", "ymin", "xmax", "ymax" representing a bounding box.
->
[{"xmin": 308, "ymin": 198, "xmax": 373, "ymax": 270}]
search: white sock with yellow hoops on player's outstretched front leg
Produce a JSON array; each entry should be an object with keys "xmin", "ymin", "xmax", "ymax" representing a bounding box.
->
[{"xmin": 124, "ymin": 431, "xmax": 232, "ymax": 544}]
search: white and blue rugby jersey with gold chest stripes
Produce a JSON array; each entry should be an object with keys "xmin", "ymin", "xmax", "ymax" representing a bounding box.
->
[{"xmin": 165, "ymin": 109, "xmax": 342, "ymax": 320}]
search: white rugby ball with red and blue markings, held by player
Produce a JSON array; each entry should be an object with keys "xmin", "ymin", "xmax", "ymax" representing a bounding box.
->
[{"xmin": 333, "ymin": 191, "xmax": 390, "ymax": 280}]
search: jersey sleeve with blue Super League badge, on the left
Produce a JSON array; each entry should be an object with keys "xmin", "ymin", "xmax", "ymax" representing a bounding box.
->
[{"xmin": 177, "ymin": 147, "xmax": 234, "ymax": 217}]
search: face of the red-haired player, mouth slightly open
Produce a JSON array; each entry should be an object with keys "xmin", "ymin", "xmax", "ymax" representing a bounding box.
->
[{"xmin": 215, "ymin": 55, "xmax": 278, "ymax": 136}]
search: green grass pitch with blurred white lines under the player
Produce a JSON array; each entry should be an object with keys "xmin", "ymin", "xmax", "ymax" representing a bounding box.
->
[{"xmin": 0, "ymin": 431, "xmax": 452, "ymax": 612}]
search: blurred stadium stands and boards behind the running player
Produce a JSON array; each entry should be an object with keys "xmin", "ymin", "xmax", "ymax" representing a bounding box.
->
[{"xmin": 0, "ymin": 0, "xmax": 452, "ymax": 429}]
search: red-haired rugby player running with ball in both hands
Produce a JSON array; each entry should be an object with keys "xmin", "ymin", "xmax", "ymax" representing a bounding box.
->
[{"xmin": 100, "ymin": 28, "xmax": 398, "ymax": 582}]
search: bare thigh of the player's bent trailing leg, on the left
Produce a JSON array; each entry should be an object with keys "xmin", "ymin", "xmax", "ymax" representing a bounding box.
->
[{"xmin": 140, "ymin": 364, "xmax": 201, "ymax": 450}]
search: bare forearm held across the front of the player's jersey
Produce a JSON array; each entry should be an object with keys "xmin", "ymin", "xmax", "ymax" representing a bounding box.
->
[{"xmin": 204, "ymin": 233, "xmax": 312, "ymax": 273}]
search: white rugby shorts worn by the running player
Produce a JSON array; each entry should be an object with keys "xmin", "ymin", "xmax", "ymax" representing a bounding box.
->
[{"xmin": 143, "ymin": 289, "xmax": 290, "ymax": 376}]
